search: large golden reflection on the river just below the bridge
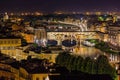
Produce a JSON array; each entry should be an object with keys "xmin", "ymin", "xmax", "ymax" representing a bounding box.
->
[{"xmin": 64, "ymin": 45, "xmax": 103, "ymax": 58}]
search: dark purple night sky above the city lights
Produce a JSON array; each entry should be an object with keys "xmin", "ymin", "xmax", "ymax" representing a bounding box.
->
[{"xmin": 0, "ymin": 0, "xmax": 120, "ymax": 12}]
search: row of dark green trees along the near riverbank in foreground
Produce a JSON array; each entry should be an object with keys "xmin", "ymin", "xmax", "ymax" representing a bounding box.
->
[{"xmin": 56, "ymin": 52, "xmax": 116, "ymax": 78}]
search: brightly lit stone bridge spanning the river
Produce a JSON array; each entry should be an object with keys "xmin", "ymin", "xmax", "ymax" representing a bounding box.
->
[{"xmin": 47, "ymin": 31, "xmax": 99, "ymax": 45}]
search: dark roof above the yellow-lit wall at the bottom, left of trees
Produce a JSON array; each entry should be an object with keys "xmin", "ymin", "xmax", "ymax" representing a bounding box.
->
[{"xmin": 21, "ymin": 59, "xmax": 49, "ymax": 73}]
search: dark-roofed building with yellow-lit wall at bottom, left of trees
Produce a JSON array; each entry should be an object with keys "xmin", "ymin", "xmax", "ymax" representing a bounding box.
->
[{"xmin": 19, "ymin": 58, "xmax": 59, "ymax": 80}]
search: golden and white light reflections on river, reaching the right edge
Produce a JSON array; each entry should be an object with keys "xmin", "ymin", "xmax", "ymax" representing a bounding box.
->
[{"xmin": 63, "ymin": 45, "xmax": 120, "ymax": 62}]
